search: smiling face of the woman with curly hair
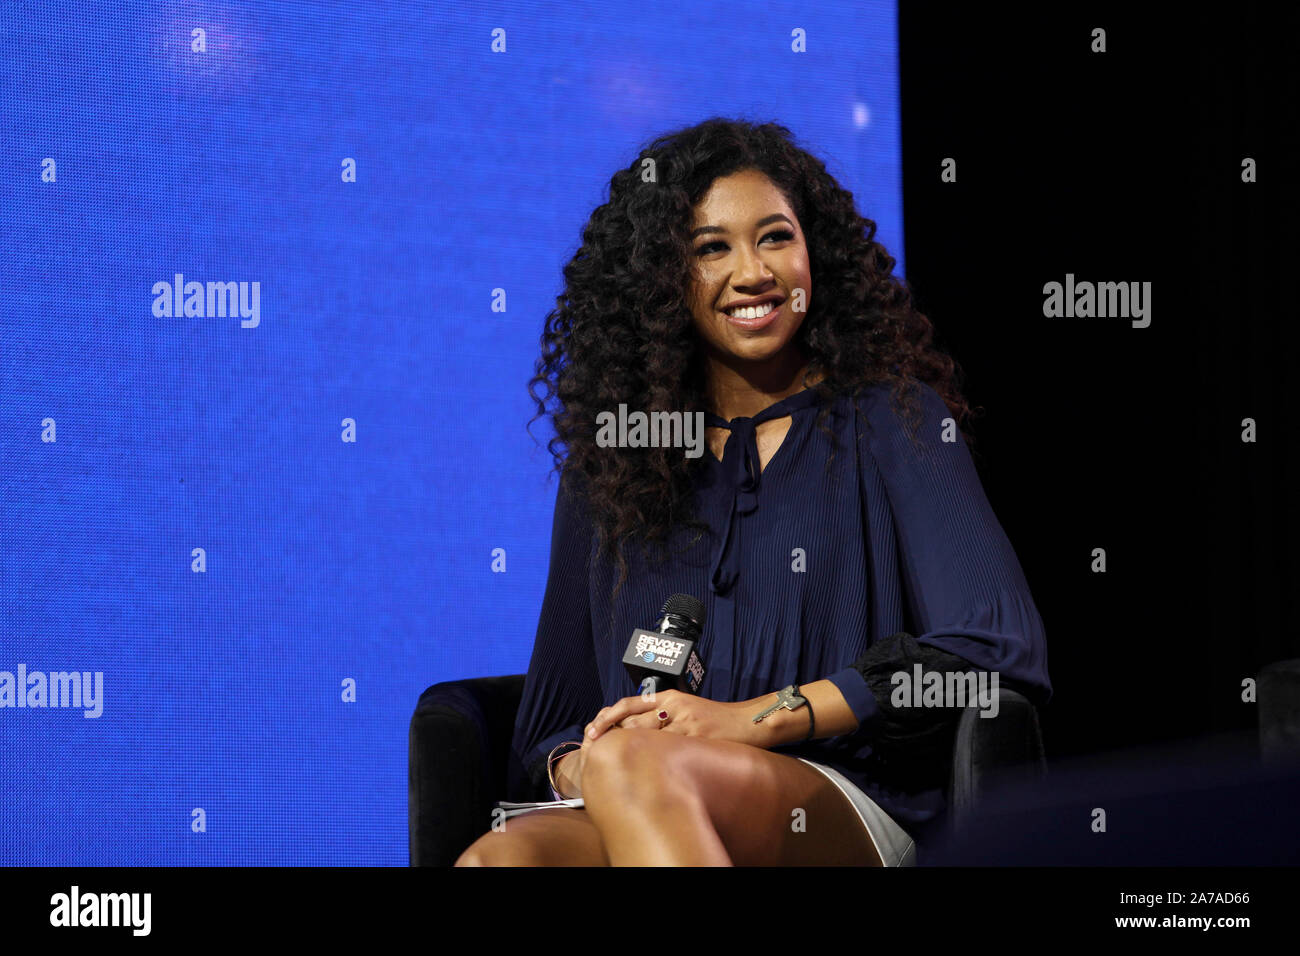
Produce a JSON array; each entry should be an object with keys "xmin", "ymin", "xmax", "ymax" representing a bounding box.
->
[{"xmin": 689, "ymin": 169, "xmax": 813, "ymax": 367}]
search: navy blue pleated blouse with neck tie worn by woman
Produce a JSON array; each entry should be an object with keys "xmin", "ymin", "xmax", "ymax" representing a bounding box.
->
[{"xmin": 511, "ymin": 382, "xmax": 1052, "ymax": 843}]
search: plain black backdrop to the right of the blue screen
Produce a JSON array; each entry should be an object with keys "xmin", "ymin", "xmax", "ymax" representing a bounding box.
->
[{"xmin": 899, "ymin": 3, "xmax": 1300, "ymax": 761}]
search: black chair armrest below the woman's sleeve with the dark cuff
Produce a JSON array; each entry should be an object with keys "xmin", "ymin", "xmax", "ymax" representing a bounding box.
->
[{"xmin": 948, "ymin": 685, "xmax": 1047, "ymax": 827}]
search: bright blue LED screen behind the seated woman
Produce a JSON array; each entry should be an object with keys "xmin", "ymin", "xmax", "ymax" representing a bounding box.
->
[{"xmin": 0, "ymin": 0, "xmax": 904, "ymax": 865}]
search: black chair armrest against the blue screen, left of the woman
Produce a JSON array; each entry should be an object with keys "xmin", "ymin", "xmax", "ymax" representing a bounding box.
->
[{"xmin": 407, "ymin": 674, "xmax": 524, "ymax": 866}]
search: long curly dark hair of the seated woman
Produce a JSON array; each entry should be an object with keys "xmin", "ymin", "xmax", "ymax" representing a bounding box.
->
[{"xmin": 528, "ymin": 117, "xmax": 974, "ymax": 593}]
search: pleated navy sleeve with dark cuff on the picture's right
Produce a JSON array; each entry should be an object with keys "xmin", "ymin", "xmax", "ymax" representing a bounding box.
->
[{"xmin": 829, "ymin": 382, "xmax": 1052, "ymax": 749}]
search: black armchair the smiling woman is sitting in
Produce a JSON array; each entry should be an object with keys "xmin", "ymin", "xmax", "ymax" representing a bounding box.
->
[{"xmin": 408, "ymin": 674, "xmax": 1047, "ymax": 866}]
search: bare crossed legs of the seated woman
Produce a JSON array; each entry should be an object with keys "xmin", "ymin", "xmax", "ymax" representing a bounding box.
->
[{"xmin": 456, "ymin": 727, "xmax": 881, "ymax": 866}]
